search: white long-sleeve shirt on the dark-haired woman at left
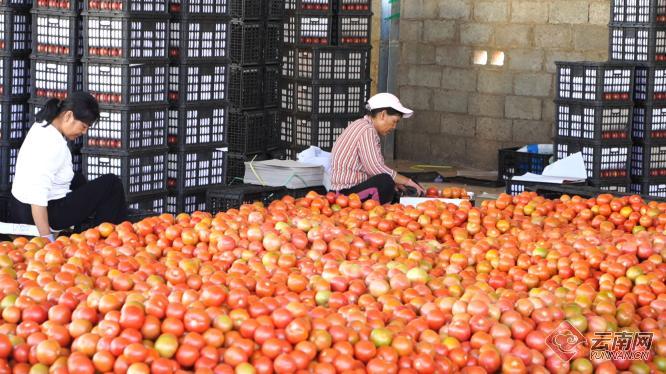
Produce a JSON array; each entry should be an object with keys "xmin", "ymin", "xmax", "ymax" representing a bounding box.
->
[{"xmin": 12, "ymin": 122, "xmax": 74, "ymax": 206}]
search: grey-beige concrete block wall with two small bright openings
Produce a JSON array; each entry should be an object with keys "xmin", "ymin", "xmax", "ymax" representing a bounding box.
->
[{"xmin": 396, "ymin": 0, "xmax": 610, "ymax": 170}]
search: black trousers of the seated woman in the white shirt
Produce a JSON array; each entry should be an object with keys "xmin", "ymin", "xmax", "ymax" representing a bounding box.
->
[{"xmin": 9, "ymin": 174, "xmax": 127, "ymax": 230}]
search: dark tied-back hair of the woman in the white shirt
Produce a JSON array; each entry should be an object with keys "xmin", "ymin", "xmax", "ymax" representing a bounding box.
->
[{"xmin": 35, "ymin": 91, "xmax": 99, "ymax": 126}]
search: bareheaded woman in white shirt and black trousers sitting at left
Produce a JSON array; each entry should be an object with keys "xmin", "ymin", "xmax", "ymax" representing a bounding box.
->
[{"xmin": 9, "ymin": 92, "xmax": 127, "ymax": 241}]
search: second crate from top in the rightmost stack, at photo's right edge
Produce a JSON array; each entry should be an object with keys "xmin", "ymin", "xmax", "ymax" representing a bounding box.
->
[{"xmin": 608, "ymin": 23, "xmax": 666, "ymax": 63}]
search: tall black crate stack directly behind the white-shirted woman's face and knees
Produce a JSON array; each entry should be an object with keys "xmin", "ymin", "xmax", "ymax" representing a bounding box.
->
[{"xmin": 79, "ymin": 0, "xmax": 169, "ymax": 213}]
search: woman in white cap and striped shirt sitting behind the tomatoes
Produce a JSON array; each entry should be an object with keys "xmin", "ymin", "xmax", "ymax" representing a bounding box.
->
[{"xmin": 330, "ymin": 93, "xmax": 425, "ymax": 204}]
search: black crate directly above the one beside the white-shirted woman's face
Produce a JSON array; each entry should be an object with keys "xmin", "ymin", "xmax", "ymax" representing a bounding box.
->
[{"xmin": 83, "ymin": 61, "xmax": 168, "ymax": 106}]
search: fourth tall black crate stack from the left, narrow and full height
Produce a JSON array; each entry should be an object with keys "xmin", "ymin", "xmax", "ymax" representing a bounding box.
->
[{"xmin": 167, "ymin": 0, "xmax": 230, "ymax": 213}]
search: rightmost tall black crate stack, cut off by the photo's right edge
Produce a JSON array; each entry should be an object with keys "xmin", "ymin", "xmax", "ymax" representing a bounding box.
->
[{"xmin": 609, "ymin": 0, "xmax": 666, "ymax": 197}]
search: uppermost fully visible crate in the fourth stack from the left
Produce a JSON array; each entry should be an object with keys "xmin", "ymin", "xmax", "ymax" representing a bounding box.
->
[{"xmin": 169, "ymin": 17, "xmax": 230, "ymax": 62}]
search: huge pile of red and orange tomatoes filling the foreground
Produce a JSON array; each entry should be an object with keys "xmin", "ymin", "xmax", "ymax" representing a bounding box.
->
[{"xmin": 0, "ymin": 192, "xmax": 666, "ymax": 374}]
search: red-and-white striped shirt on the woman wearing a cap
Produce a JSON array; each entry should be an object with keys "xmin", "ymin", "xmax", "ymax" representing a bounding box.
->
[{"xmin": 331, "ymin": 116, "xmax": 397, "ymax": 191}]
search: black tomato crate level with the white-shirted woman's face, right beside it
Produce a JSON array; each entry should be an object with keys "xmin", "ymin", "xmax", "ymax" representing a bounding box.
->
[{"xmin": 83, "ymin": 106, "xmax": 167, "ymax": 151}]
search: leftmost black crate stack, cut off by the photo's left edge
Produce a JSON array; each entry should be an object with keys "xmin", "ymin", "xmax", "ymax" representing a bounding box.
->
[{"xmin": 0, "ymin": 0, "xmax": 31, "ymax": 221}]
